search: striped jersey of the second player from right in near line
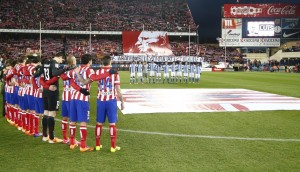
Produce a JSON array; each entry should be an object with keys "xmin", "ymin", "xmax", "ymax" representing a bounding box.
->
[{"xmin": 68, "ymin": 65, "xmax": 95, "ymax": 101}]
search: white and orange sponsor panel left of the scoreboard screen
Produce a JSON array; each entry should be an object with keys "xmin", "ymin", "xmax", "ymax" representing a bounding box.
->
[{"xmin": 222, "ymin": 18, "xmax": 242, "ymax": 39}]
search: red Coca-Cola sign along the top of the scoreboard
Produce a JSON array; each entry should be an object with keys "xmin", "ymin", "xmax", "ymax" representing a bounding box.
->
[{"xmin": 224, "ymin": 4, "xmax": 300, "ymax": 18}]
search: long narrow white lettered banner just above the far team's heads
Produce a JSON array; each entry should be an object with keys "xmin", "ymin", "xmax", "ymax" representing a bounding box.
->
[{"xmin": 112, "ymin": 55, "xmax": 204, "ymax": 62}]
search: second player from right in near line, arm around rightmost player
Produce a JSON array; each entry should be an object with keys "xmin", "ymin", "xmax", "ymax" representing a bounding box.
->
[{"xmin": 67, "ymin": 54, "xmax": 114, "ymax": 152}]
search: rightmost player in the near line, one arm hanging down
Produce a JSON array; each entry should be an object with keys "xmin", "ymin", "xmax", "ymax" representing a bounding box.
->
[{"xmin": 91, "ymin": 56, "xmax": 124, "ymax": 152}]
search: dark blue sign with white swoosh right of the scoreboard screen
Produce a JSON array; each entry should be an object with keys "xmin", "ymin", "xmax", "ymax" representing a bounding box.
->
[{"xmin": 281, "ymin": 18, "xmax": 300, "ymax": 39}]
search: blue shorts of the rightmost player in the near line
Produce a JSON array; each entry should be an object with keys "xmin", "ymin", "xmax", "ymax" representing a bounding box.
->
[{"xmin": 96, "ymin": 99, "xmax": 118, "ymax": 123}]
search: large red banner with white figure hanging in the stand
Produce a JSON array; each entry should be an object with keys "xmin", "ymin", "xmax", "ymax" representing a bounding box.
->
[{"xmin": 122, "ymin": 31, "xmax": 173, "ymax": 56}]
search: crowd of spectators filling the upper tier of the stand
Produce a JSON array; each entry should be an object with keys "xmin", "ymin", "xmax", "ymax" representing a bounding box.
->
[{"xmin": 0, "ymin": 0, "xmax": 196, "ymax": 32}]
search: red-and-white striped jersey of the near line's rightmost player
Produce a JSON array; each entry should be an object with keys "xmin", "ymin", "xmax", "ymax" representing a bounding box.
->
[{"xmin": 96, "ymin": 67, "xmax": 120, "ymax": 101}]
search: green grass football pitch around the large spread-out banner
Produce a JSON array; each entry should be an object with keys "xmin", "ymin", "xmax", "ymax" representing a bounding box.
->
[{"xmin": 0, "ymin": 72, "xmax": 300, "ymax": 172}]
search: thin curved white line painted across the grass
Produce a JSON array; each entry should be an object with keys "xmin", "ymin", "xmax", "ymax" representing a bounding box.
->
[{"xmin": 55, "ymin": 119, "xmax": 300, "ymax": 142}]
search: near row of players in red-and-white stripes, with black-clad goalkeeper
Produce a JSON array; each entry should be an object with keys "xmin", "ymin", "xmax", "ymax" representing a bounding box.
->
[{"xmin": 4, "ymin": 53, "xmax": 124, "ymax": 152}]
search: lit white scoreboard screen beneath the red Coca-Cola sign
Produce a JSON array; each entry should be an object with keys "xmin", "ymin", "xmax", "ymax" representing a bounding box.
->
[{"xmin": 242, "ymin": 18, "xmax": 282, "ymax": 38}]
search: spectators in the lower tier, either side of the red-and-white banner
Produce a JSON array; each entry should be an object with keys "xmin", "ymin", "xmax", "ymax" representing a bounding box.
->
[{"xmin": 0, "ymin": 35, "xmax": 241, "ymax": 64}]
